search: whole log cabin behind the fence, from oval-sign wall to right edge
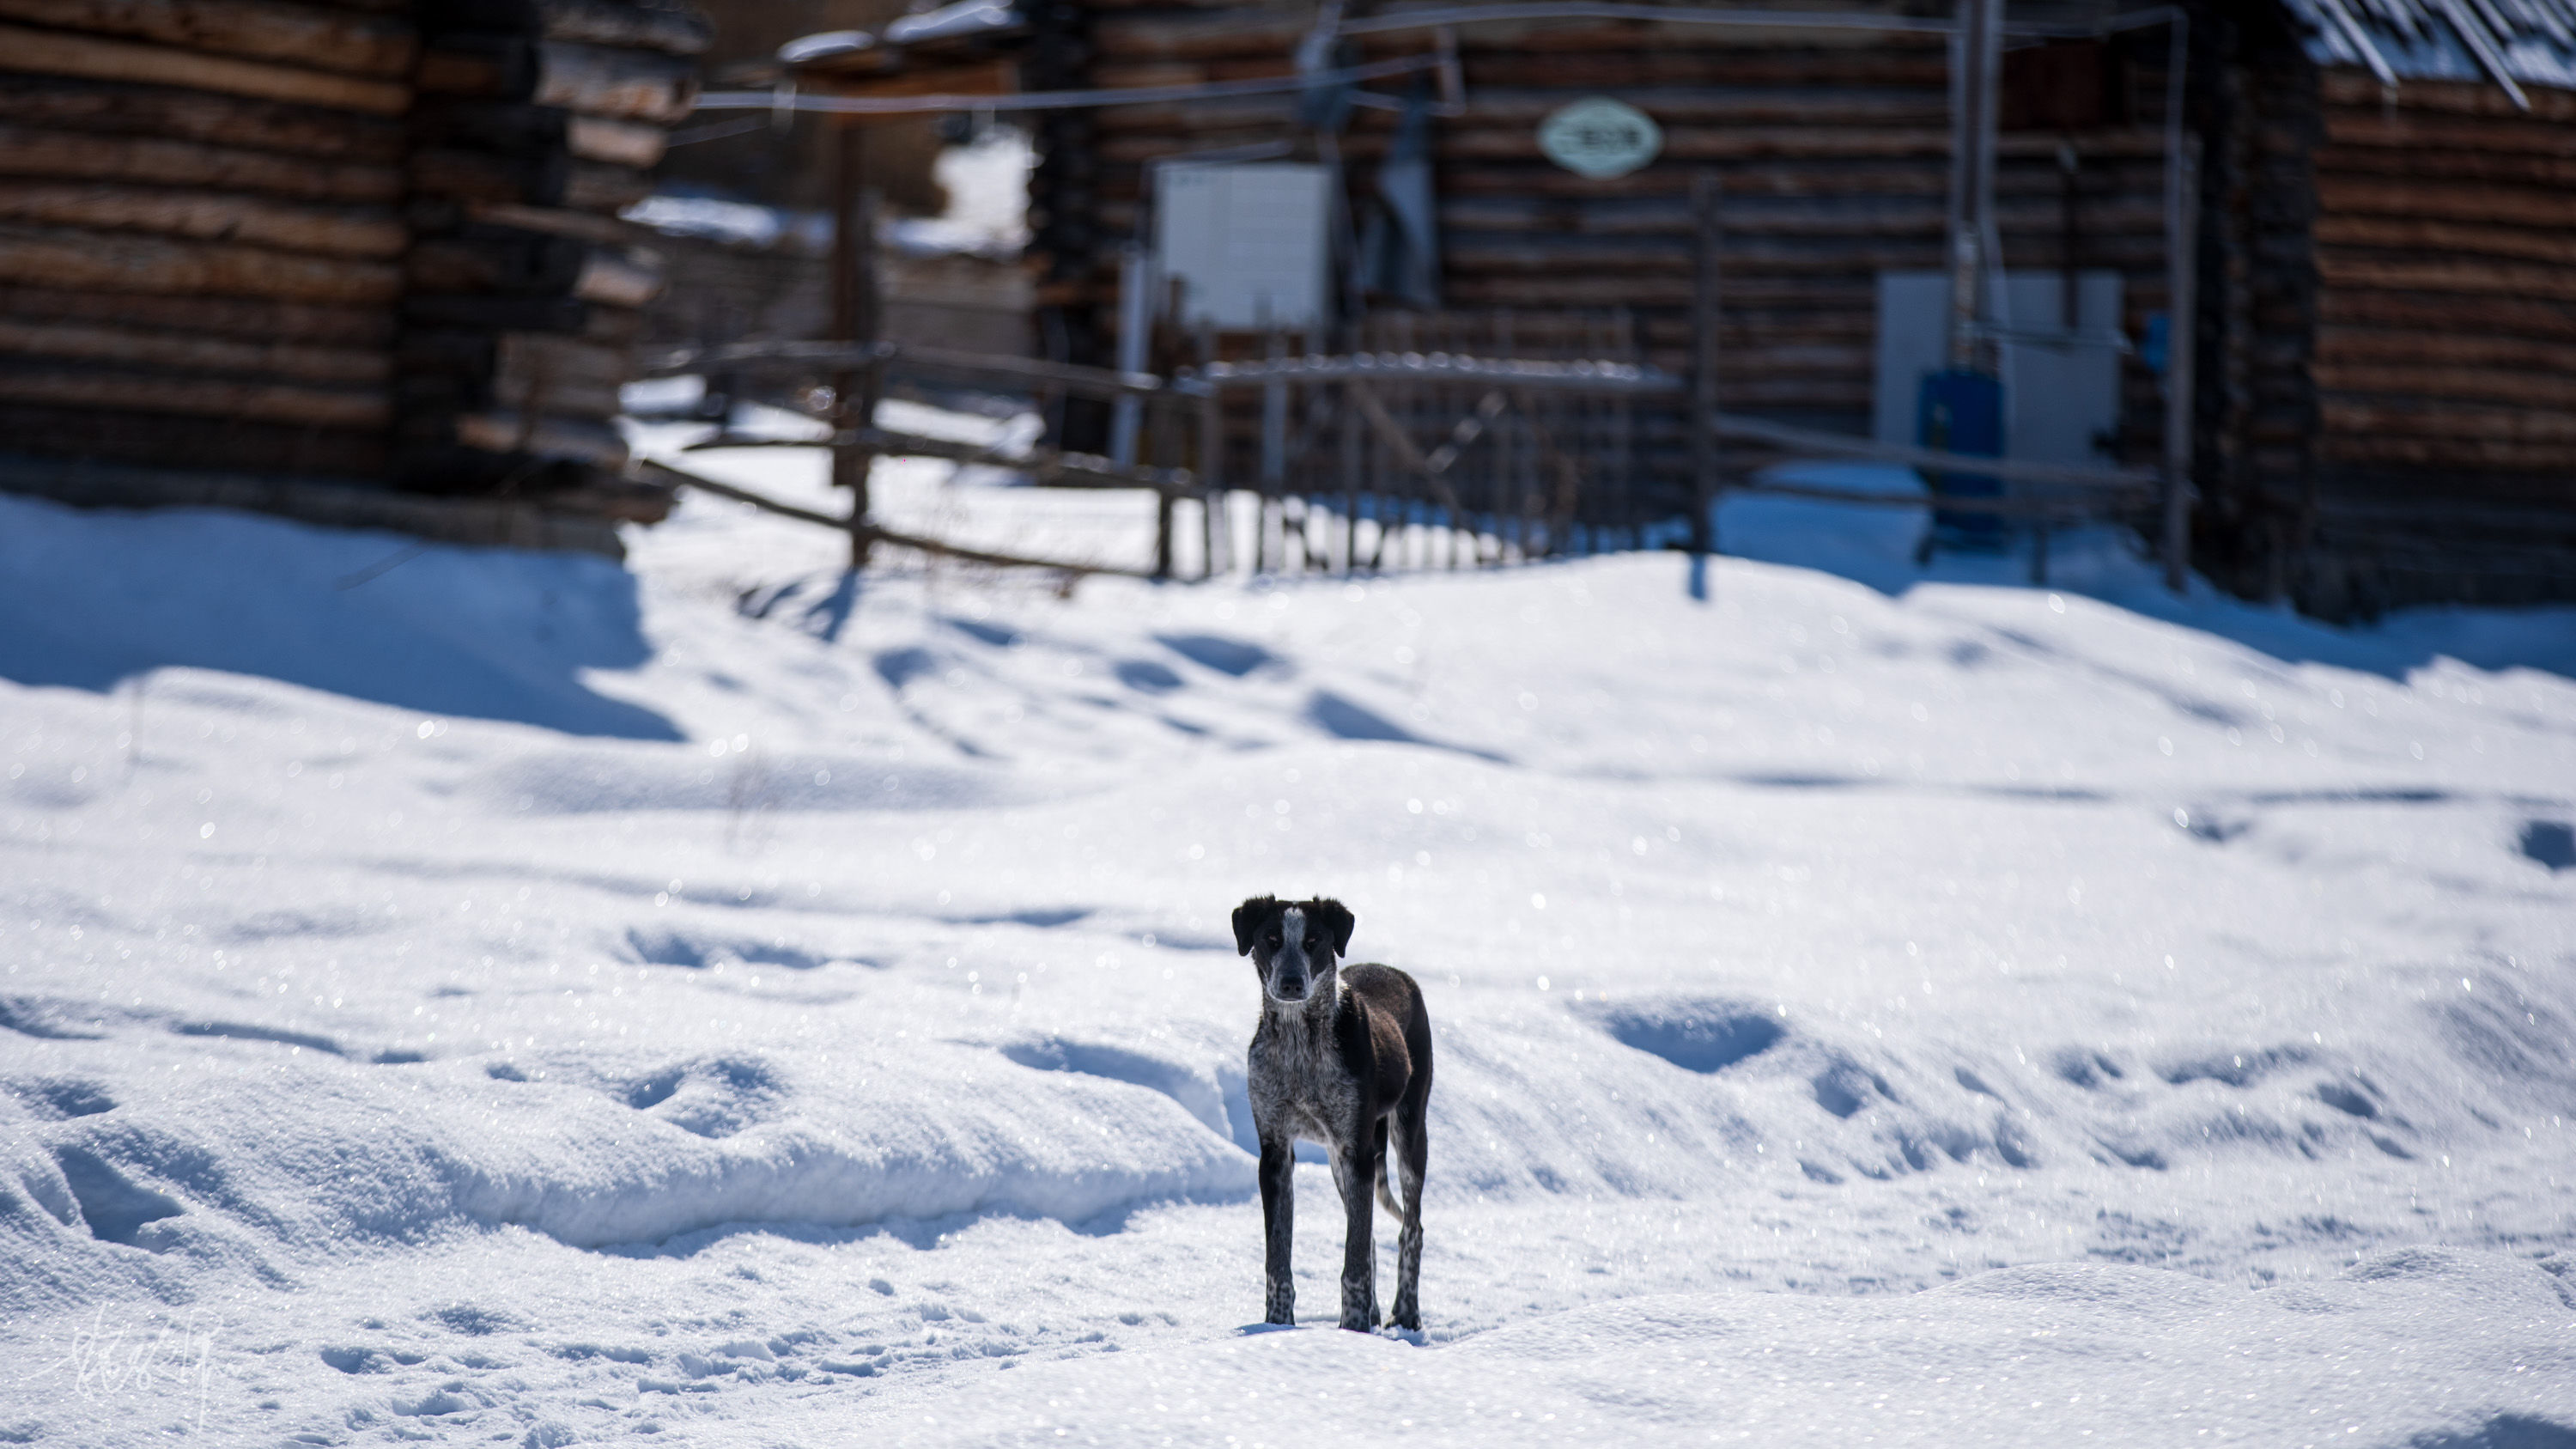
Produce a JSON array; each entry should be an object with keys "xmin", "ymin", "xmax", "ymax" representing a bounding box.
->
[{"xmin": 788, "ymin": 0, "xmax": 2576, "ymax": 618}]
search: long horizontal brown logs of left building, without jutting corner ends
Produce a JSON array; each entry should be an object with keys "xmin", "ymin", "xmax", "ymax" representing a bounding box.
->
[{"xmin": 0, "ymin": 0, "xmax": 417, "ymax": 477}]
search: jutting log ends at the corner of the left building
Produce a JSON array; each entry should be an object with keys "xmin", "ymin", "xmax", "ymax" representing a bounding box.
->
[{"xmin": 397, "ymin": 0, "xmax": 708, "ymax": 492}]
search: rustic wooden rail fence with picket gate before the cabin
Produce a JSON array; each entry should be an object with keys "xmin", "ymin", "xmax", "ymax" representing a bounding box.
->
[{"xmin": 634, "ymin": 317, "xmax": 2172, "ymax": 577}]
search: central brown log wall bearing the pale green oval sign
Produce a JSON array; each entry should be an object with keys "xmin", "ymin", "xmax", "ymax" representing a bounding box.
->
[{"xmin": 1038, "ymin": 0, "xmax": 2164, "ymax": 497}]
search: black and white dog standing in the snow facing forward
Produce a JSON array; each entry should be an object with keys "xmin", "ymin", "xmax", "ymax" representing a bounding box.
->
[{"xmin": 1234, "ymin": 895, "xmax": 1432, "ymax": 1333}]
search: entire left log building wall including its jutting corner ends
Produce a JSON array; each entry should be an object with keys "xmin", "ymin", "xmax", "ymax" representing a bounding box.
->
[{"xmin": 0, "ymin": 0, "xmax": 706, "ymax": 513}]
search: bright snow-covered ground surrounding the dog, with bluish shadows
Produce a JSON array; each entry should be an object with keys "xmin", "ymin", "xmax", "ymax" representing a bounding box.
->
[{"xmin": 0, "ymin": 412, "xmax": 2576, "ymax": 1449}]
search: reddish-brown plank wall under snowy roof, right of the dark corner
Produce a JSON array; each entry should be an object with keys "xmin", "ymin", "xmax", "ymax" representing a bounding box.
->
[{"xmin": 2295, "ymin": 70, "xmax": 2576, "ymax": 616}]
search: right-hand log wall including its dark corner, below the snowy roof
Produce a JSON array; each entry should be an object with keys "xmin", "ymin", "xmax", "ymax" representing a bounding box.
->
[{"xmin": 2192, "ymin": 5, "xmax": 2576, "ymax": 618}]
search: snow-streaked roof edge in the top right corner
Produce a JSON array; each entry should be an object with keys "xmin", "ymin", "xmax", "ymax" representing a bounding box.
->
[{"xmin": 2287, "ymin": 0, "xmax": 2576, "ymax": 103}]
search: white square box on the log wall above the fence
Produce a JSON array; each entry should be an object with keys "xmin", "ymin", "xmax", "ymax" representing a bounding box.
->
[{"xmin": 1154, "ymin": 162, "xmax": 1332, "ymax": 330}]
